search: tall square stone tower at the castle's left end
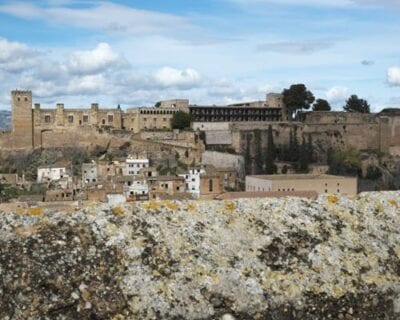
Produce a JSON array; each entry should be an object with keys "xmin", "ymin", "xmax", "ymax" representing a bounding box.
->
[{"xmin": 11, "ymin": 90, "xmax": 33, "ymax": 148}]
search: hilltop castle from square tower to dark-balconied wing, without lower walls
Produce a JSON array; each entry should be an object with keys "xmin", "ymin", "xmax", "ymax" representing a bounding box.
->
[{"xmin": 0, "ymin": 90, "xmax": 286, "ymax": 149}]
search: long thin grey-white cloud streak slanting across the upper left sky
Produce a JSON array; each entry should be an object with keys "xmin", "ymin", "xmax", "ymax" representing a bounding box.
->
[{"xmin": 0, "ymin": 1, "xmax": 192, "ymax": 35}]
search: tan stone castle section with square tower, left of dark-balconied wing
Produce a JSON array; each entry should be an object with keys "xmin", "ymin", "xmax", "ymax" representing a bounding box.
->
[{"xmin": 7, "ymin": 90, "xmax": 189, "ymax": 149}]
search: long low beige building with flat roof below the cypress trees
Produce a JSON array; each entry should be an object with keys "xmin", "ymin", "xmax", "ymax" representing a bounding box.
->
[{"xmin": 246, "ymin": 174, "xmax": 357, "ymax": 195}]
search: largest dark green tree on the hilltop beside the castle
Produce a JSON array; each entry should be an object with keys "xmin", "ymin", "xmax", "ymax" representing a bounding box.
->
[{"xmin": 282, "ymin": 84, "xmax": 315, "ymax": 119}]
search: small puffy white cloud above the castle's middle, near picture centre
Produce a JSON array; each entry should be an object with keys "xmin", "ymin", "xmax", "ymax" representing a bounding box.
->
[{"xmin": 154, "ymin": 67, "xmax": 201, "ymax": 88}]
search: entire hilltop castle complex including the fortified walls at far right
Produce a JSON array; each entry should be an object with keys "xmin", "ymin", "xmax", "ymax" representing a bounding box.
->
[{"xmin": 0, "ymin": 90, "xmax": 400, "ymax": 158}]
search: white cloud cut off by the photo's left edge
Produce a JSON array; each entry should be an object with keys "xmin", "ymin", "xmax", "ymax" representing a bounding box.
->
[{"xmin": 0, "ymin": 38, "xmax": 38, "ymax": 72}]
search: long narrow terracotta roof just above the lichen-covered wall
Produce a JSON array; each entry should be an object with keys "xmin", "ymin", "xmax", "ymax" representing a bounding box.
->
[{"xmin": 215, "ymin": 191, "xmax": 318, "ymax": 200}]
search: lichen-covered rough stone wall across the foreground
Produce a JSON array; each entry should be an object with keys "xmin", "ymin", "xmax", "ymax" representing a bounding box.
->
[{"xmin": 0, "ymin": 192, "xmax": 400, "ymax": 320}]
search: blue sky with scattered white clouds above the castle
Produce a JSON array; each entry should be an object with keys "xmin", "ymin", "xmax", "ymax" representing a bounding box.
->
[{"xmin": 0, "ymin": 0, "xmax": 400, "ymax": 112}]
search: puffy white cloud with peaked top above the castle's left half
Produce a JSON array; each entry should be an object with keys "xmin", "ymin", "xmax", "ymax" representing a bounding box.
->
[{"xmin": 67, "ymin": 43, "xmax": 128, "ymax": 74}]
